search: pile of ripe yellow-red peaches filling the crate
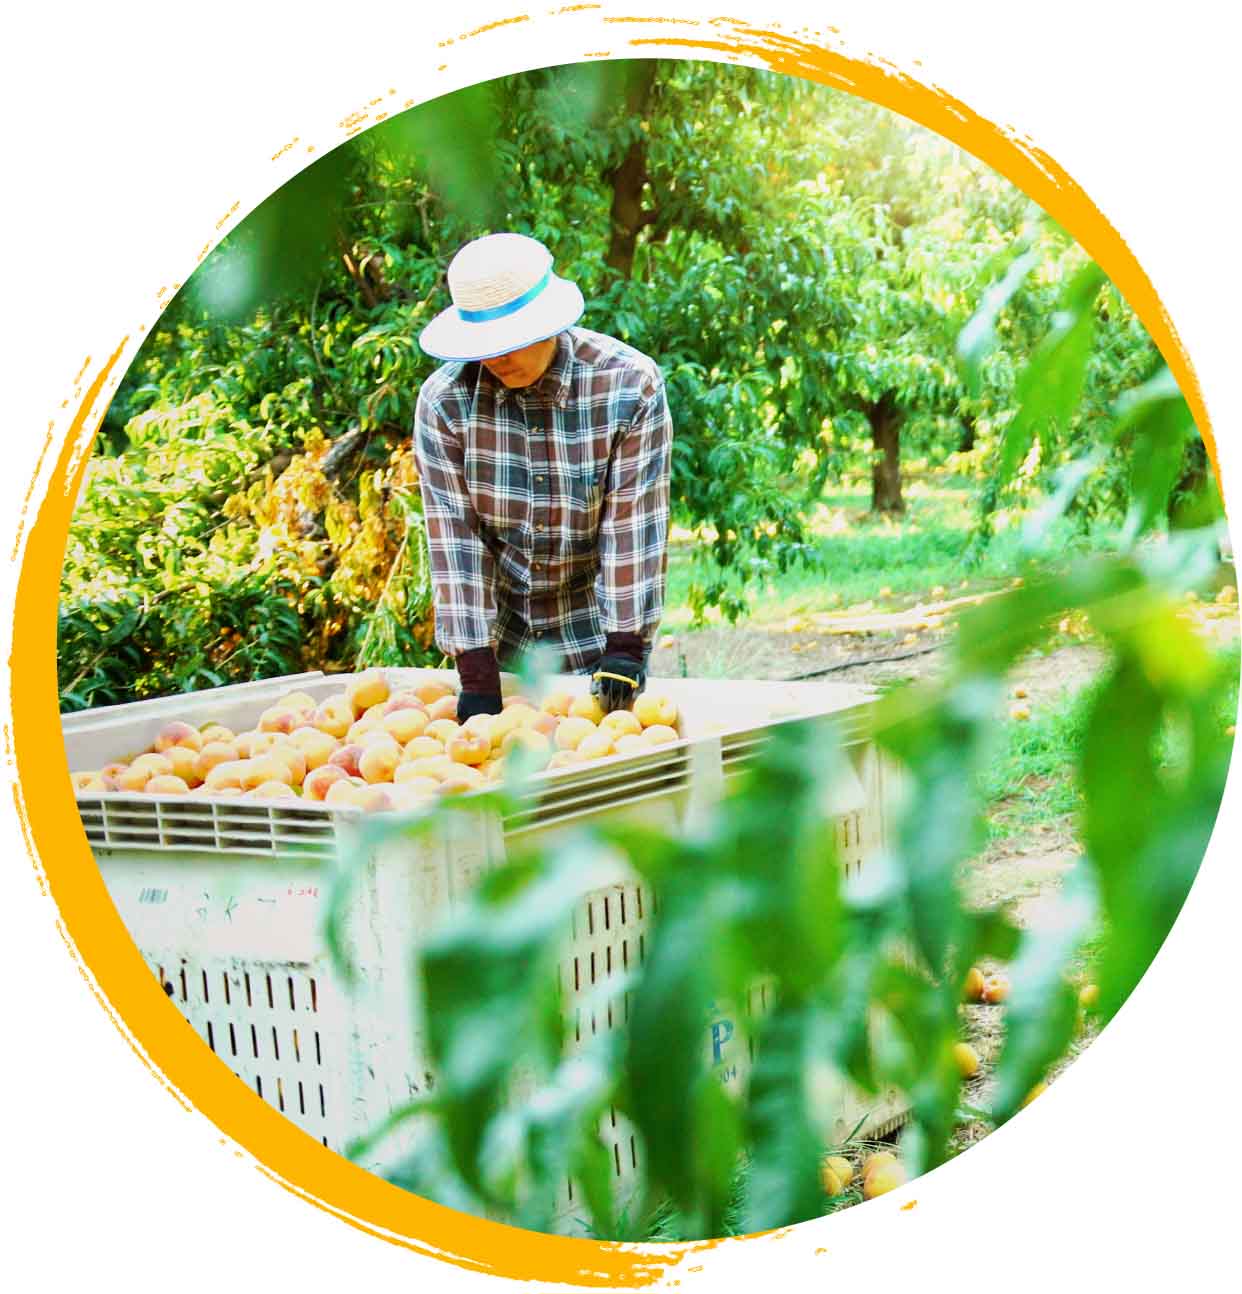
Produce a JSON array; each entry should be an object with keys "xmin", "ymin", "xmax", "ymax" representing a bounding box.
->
[{"xmin": 71, "ymin": 669, "xmax": 681, "ymax": 811}]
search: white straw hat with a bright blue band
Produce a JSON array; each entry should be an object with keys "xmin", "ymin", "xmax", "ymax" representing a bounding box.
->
[{"xmin": 418, "ymin": 234, "xmax": 585, "ymax": 360}]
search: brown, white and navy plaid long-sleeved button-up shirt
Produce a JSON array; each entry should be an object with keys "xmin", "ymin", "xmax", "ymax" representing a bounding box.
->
[{"xmin": 414, "ymin": 327, "xmax": 673, "ymax": 669}]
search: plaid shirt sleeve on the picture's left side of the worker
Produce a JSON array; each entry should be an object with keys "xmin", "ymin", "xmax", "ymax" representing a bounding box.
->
[{"xmin": 414, "ymin": 393, "xmax": 496, "ymax": 657}]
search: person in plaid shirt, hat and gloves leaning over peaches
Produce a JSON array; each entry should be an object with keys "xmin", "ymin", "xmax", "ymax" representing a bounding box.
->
[{"xmin": 414, "ymin": 234, "xmax": 673, "ymax": 721}]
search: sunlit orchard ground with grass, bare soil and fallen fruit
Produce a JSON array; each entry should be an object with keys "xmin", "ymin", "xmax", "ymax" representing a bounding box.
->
[{"xmin": 652, "ymin": 472, "xmax": 1239, "ymax": 1174}]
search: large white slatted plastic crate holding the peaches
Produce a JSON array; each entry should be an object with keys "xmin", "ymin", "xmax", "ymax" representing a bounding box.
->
[{"xmin": 63, "ymin": 669, "xmax": 906, "ymax": 1229}]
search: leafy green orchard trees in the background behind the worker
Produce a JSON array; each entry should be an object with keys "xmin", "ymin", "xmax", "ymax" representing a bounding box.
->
[{"xmin": 60, "ymin": 60, "xmax": 1185, "ymax": 709}]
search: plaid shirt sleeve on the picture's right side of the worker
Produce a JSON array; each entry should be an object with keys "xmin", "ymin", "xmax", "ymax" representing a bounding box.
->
[{"xmin": 596, "ymin": 378, "xmax": 673, "ymax": 638}]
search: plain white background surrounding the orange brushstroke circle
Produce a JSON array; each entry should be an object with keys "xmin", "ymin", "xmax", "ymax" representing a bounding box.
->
[{"xmin": 0, "ymin": 0, "xmax": 1242, "ymax": 1291}]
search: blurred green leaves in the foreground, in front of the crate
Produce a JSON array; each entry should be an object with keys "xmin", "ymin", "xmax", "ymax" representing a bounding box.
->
[{"xmin": 324, "ymin": 278, "xmax": 1238, "ymax": 1240}]
